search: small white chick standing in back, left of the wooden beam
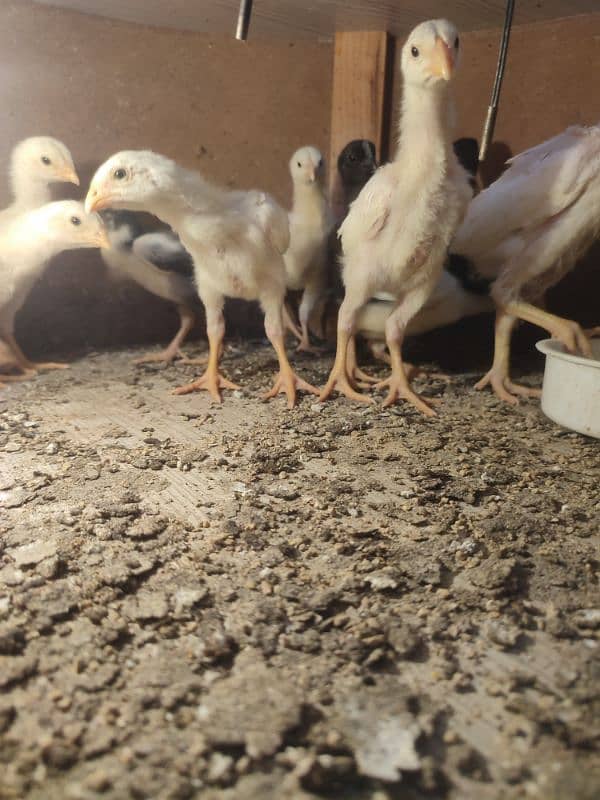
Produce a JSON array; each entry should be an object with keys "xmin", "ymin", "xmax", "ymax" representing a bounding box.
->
[{"xmin": 283, "ymin": 147, "xmax": 333, "ymax": 352}]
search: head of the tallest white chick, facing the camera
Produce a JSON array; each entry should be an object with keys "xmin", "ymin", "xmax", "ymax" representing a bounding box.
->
[{"xmin": 401, "ymin": 19, "xmax": 460, "ymax": 87}]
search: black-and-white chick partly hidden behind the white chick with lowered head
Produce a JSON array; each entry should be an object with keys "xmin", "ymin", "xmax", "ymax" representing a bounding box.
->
[{"xmin": 101, "ymin": 211, "xmax": 197, "ymax": 364}]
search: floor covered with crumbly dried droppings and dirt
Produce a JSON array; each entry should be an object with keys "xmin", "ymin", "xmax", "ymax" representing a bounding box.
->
[{"xmin": 0, "ymin": 345, "xmax": 600, "ymax": 800}]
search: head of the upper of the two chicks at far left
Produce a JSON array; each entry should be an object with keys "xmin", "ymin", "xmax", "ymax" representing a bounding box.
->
[{"xmin": 11, "ymin": 136, "xmax": 79, "ymax": 186}]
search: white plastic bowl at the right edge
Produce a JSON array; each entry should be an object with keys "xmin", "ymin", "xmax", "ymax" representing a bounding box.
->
[{"xmin": 536, "ymin": 339, "xmax": 600, "ymax": 439}]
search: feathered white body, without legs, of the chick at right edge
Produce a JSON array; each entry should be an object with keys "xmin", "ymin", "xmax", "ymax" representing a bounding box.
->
[{"xmin": 452, "ymin": 126, "xmax": 600, "ymax": 302}]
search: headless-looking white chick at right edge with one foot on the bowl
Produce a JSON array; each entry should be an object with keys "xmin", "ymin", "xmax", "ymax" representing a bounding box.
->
[{"xmin": 452, "ymin": 125, "xmax": 600, "ymax": 404}]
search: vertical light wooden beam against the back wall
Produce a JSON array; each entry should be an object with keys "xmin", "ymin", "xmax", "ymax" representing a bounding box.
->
[{"xmin": 329, "ymin": 31, "xmax": 389, "ymax": 214}]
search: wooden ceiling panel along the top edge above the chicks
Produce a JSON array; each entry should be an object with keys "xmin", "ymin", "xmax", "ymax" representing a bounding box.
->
[{"xmin": 38, "ymin": 0, "xmax": 598, "ymax": 39}]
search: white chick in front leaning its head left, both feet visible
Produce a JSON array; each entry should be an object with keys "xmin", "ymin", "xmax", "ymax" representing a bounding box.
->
[{"xmin": 86, "ymin": 151, "xmax": 317, "ymax": 407}]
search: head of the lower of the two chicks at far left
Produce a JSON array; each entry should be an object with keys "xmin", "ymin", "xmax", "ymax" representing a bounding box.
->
[{"xmin": 42, "ymin": 200, "xmax": 110, "ymax": 250}]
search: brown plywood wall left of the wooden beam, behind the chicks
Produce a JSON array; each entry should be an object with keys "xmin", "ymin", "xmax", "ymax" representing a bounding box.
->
[{"xmin": 0, "ymin": 0, "xmax": 332, "ymax": 348}]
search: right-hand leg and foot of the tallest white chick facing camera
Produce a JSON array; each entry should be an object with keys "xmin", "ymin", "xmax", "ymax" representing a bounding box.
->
[{"xmin": 375, "ymin": 287, "xmax": 435, "ymax": 417}]
